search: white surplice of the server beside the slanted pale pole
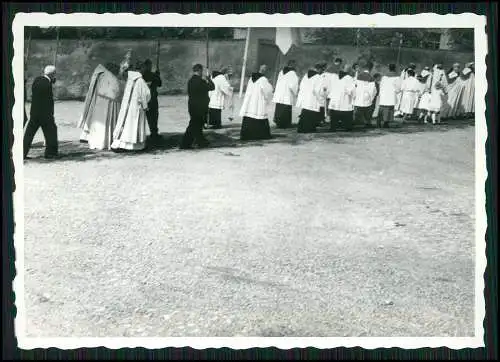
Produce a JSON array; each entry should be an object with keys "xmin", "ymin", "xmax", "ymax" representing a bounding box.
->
[{"xmin": 240, "ymin": 76, "xmax": 273, "ymax": 119}]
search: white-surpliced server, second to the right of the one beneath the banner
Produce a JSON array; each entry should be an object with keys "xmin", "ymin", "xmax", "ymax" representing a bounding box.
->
[{"xmin": 328, "ymin": 64, "xmax": 356, "ymax": 132}]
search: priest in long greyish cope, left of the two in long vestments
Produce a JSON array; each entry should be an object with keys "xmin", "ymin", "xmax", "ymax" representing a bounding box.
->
[{"xmin": 78, "ymin": 64, "xmax": 122, "ymax": 150}]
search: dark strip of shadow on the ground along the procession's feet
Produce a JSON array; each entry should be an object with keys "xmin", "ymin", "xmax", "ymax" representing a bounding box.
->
[{"xmin": 23, "ymin": 119, "xmax": 474, "ymax": 163}]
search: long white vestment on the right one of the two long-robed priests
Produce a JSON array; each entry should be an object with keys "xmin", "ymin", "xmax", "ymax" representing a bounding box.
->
[{"xmin": 111, "ymin": 71, "xmax": 151, "ymax": 150}]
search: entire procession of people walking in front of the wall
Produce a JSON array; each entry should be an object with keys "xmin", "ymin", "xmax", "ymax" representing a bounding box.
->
[{"xmin": 23, "ymin": 52, "xmax": 475, "ymax": 158}]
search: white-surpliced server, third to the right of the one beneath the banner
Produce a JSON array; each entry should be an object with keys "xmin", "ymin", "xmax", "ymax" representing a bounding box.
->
[{"xmin": 354, "ymin": 62, "xmax": 377, "ymax": 128}]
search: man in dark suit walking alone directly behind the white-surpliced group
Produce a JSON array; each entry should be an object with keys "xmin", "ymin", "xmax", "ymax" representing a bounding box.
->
[{"xmin": 180, "ymin": 64, "xmax": 215, "ymax": 149}]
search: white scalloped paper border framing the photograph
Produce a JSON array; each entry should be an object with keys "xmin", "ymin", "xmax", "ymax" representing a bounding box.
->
[{"xmin": 12, "ymin": 13, "xmax": 488, "ymax": 350}]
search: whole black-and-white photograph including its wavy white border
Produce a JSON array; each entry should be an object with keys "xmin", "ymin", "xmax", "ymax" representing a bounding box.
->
[{"xmin": 13, "ymin": 13, "xmax": 487, "ymax": 348}]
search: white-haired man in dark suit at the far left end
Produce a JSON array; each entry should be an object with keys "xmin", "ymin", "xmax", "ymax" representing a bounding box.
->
[{"xmin": 24, "ymin": 65, "xmax": 58, "ymax": 159}]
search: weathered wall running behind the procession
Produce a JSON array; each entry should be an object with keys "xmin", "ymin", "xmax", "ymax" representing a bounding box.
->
[{"xmin": 25, "ymin": 37, "xmax": 474, "ymax": 99}]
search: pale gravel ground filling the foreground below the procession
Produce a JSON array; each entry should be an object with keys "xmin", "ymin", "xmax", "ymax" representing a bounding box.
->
[{"xmin": 24, "ymin": 97, "xmax": 475, "ymax": 337}]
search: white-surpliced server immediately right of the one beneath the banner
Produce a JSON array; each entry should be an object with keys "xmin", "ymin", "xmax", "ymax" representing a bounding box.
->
[{"xmin": 297, "ymin": 64, "xmax": 325, "ymax": 133}]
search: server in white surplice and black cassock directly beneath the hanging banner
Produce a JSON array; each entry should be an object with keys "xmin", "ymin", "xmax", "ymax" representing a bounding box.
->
[{"xmin": 273, "ymin": 60, "xmax": 299, "ymax": 128}]
